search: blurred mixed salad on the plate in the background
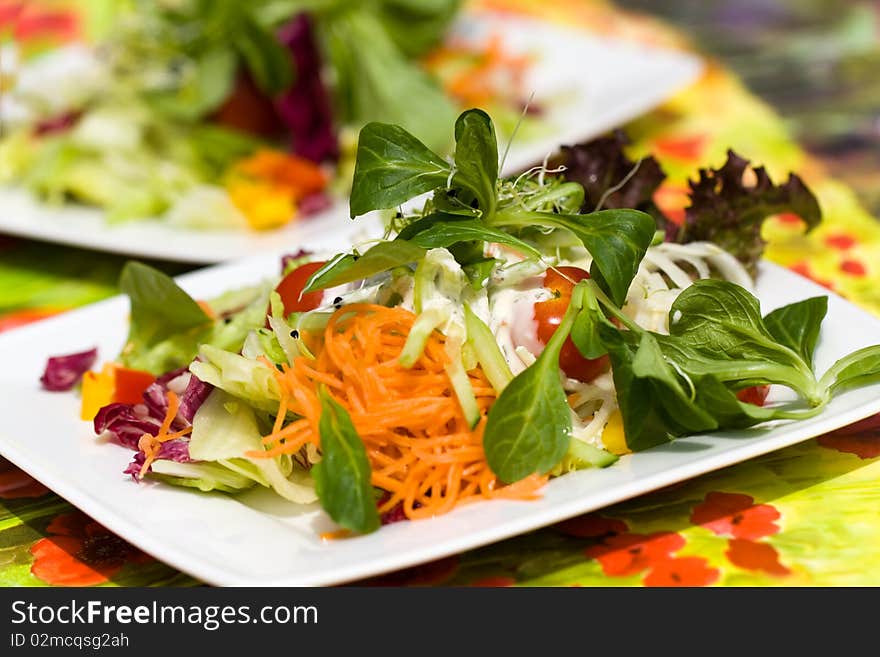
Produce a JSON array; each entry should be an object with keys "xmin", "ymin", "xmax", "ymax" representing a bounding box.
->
[{"xmin": 0, "ymin": 0, "xmax": 525, "ymax": 230}]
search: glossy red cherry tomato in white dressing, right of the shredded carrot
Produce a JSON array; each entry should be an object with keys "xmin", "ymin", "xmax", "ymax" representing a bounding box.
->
[{"xmin": 535, "ymin": 267, "xmax": 608, "ymax": 381}]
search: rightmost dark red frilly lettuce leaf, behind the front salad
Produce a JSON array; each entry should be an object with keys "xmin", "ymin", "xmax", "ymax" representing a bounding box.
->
[{"xmin": 667, "ymin": 150, "xmax": 822, "ymax": 273}]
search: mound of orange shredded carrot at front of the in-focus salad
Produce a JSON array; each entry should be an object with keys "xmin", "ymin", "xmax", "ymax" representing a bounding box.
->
[{"xmin": 248, "ymin": 304, "xmax": 547, "ymax": 519}]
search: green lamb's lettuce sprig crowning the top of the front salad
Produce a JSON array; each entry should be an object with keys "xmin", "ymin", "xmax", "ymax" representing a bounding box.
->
[{"xmin": 306, "ymin": 109, "xmax": 655, "ymax": 310}]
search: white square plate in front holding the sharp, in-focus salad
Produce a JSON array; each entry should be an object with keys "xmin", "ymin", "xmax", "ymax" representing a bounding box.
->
[{"xmin": 0, "ymin": 257, "xmax": 880, "ymax": 586}]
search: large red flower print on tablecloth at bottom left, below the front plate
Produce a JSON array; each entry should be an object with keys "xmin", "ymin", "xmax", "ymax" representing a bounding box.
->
[{"xmin": 31, "ymin": 511, "xmax": 152, "ymax": 586}]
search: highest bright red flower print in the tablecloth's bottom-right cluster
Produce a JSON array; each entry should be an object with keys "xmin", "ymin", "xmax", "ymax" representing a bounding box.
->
[{"xmin": 691, "ymin": 492, "xmax": 780, "ymax": 539}]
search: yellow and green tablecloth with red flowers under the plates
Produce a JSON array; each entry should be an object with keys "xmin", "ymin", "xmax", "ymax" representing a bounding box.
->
[{"xmin": 0, "ymin": 0, "xmax": 880, "ymax": 586}]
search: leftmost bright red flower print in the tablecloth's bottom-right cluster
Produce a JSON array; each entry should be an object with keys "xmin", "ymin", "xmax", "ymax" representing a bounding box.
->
[{"xmin": 584, "ymin": 532, "xmax": 685, "ymax": 577}]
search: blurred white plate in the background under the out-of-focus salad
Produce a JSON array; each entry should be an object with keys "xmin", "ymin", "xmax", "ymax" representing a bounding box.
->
[{"xmin": 0, "ymin": 13, "xmax": 702, "ymax": 263}]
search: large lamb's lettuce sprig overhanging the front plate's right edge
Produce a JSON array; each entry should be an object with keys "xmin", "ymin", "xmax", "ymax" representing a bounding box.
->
[{"xmin": 572, "ymin": 279, "xmax": 880, "ymax": 451}]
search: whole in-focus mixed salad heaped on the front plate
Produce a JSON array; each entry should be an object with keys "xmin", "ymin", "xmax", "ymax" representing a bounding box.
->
[{"xmin": 44, "ymin": 110, "xmax": 880, "ymax": 533}]
